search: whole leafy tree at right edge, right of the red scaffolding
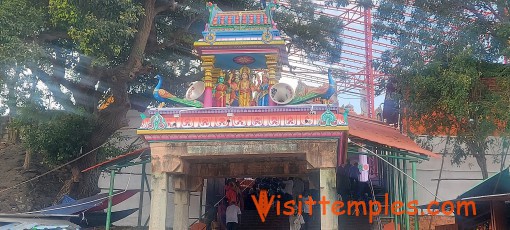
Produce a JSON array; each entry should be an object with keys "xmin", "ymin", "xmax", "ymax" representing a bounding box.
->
[{"xmin": 374, "ymin": 0, "xmax": 510, "ymax": 178}]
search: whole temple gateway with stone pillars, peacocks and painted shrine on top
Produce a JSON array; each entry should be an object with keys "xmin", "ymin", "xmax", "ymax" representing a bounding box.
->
[{"xmin": 137, "ymin": 2, "xmax": 348, "ymax": 230}]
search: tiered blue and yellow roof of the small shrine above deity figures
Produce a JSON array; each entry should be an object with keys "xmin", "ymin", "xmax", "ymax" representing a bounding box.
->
[{"xmin": 194, "ymin": 3, "xmax": 288, "ymax": 69}]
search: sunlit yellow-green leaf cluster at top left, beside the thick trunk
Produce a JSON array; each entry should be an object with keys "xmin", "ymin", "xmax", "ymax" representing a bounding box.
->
[{"xmin": 49, "ymin": 0, "xmax": 143, "ymax": 66}]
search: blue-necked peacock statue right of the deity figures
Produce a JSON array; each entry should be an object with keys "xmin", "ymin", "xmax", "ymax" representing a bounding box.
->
[{"xmin": 289, "ymin": 68, "xmax": 336, "ymax": 105}]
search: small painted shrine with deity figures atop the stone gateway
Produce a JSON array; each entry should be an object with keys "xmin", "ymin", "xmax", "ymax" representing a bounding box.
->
[{"xmin": 195, "ymin": 3, "xmax": 287, "ymax": 107}]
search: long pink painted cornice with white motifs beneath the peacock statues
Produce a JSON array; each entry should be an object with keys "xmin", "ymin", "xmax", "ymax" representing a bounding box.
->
[{"xmin": 138, "ymin": 106, "xmax": 348, "ymax": 134}]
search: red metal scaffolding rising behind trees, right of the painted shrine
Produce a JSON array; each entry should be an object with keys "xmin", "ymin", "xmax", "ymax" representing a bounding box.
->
[{"xmin": 280, "ymin": 1, "xmax": 394, "ymax": 118}]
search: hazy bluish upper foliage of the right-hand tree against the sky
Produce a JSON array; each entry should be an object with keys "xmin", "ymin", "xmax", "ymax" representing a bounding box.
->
[{"xmin": 374, "ymin": 0, "xmax": 510, "ymax": 61}]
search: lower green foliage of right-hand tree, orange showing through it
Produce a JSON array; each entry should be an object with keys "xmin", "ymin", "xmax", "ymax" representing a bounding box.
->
[{"xmin": 388, "ymin": 49, "xmax": 510, "ymax": 176}]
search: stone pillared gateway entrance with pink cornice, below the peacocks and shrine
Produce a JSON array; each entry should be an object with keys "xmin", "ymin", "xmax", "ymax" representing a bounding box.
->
[{"xmin": 138, "ymin": 105, "xmax": 348, "ymax": 230}]
